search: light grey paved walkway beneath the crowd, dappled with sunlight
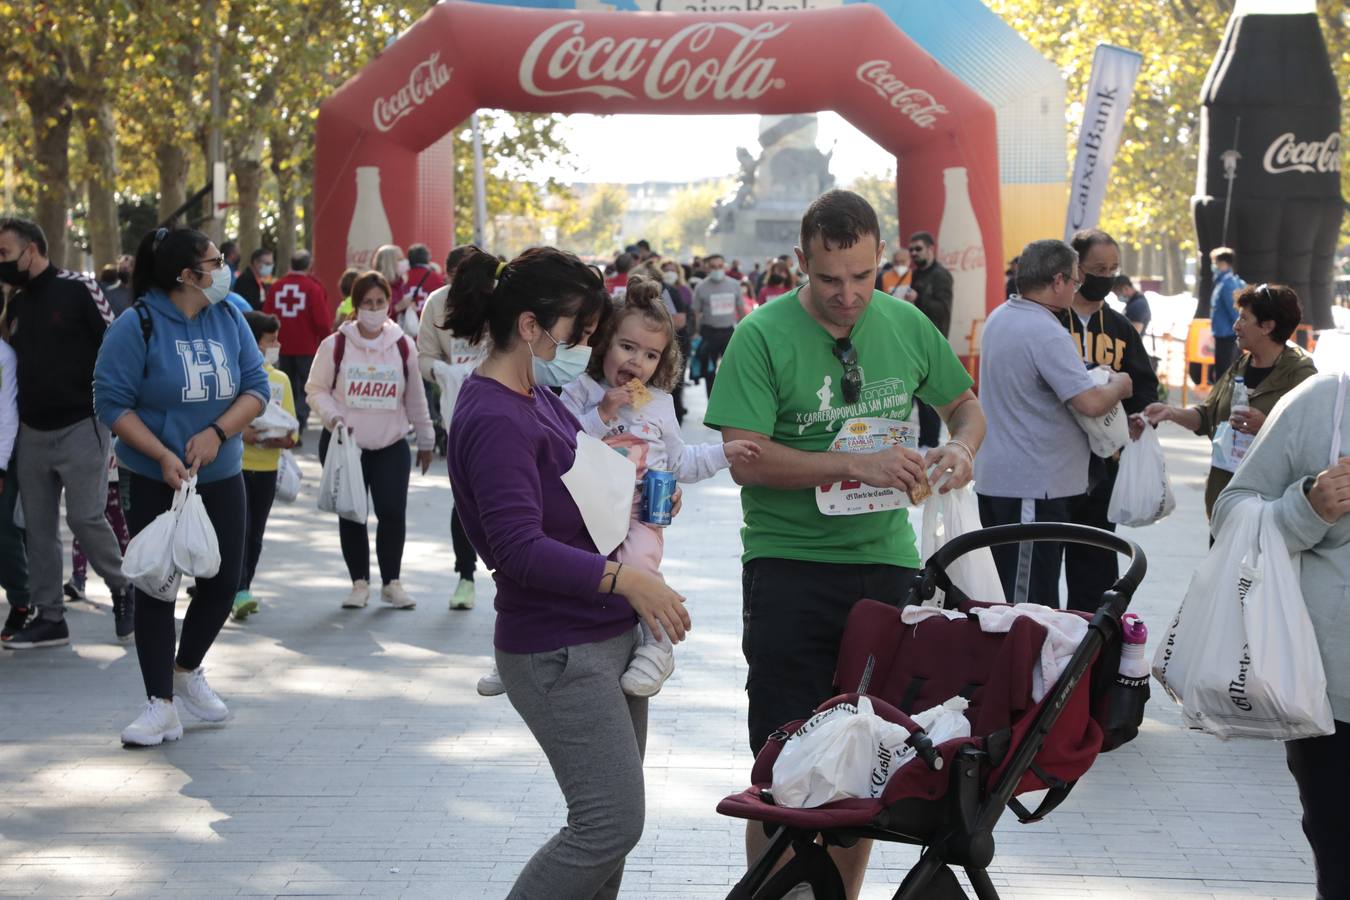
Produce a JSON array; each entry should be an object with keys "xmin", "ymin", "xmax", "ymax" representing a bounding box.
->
[{"xmin": 0, "ymin": 390, "xmax": 1314, "ymax": 900}]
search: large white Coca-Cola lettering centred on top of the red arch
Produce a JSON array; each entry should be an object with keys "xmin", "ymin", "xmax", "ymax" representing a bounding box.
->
[{"xmin": 520, "ymin": 19, "xmax": 787, "ymax": 100}]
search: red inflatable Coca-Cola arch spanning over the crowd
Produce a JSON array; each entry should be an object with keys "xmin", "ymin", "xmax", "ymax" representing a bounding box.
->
[{"xmin": 313, "ymin": 3, "xmax": 1003, "ymax": 352}]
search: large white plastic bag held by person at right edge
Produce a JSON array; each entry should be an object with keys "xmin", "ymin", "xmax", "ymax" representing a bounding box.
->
[{"xmin": 1153, "ymin": 498, "xmax": 1335, "ymax": 741}]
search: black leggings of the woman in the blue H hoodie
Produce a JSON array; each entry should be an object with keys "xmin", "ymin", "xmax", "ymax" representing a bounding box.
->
[{"xmin": 122, "ymin": 470, "xmax": 244, "ymax": 700}]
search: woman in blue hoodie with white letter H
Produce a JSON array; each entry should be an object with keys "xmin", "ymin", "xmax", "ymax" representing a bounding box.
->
[{"xmin": 93, "ymin": 228, "xmax": 269, "ymax": 746}]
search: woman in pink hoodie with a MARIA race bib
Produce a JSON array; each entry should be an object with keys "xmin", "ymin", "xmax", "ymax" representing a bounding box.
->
[{"xmin": 305, "ymin": 271, "xmax": 436, "ymax": 609}]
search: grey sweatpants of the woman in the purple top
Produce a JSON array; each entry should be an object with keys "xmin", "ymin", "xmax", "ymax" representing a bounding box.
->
[{"xmin": 497, "ymin": 627, "xmax": 647, "ymax": 900}]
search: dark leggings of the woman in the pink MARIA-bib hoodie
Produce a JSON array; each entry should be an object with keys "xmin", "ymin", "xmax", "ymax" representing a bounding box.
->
[{"xmin": 319, "ymin": 429, "xmax": 413, "ymax": 584}]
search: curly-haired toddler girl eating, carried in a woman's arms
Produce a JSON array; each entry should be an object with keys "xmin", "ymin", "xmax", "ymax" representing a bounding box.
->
[{"xmin": 563, "ymin": 277, "xmax": 760, "ymax": 696}]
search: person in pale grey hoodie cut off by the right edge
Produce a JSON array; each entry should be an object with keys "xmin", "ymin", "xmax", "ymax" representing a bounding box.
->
[{"xmin": 1214, "ymin": 375, "xmax": 1350, "ymax": 900}]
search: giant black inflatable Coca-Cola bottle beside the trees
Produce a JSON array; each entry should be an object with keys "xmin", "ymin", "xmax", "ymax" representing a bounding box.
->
[{"xmin": 1192, "ymin": 0, "xmax": 1343, "ymax": 328}]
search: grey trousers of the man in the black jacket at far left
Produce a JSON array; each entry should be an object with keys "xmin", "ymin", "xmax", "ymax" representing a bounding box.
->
[{"xmin": 18, "ymin": 418, "xmax": 127, "ymax": 622}]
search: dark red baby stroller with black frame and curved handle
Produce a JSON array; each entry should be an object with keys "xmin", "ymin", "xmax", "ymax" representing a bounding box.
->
[{"xmin": 717, "ymin": 524, "xmax": 1146, "ymax": 900}]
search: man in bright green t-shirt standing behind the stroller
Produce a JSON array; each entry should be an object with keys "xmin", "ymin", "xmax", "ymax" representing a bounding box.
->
[{"xmin": 705, "ymin": 190, "xmax": 984, "ymax": 897}]
